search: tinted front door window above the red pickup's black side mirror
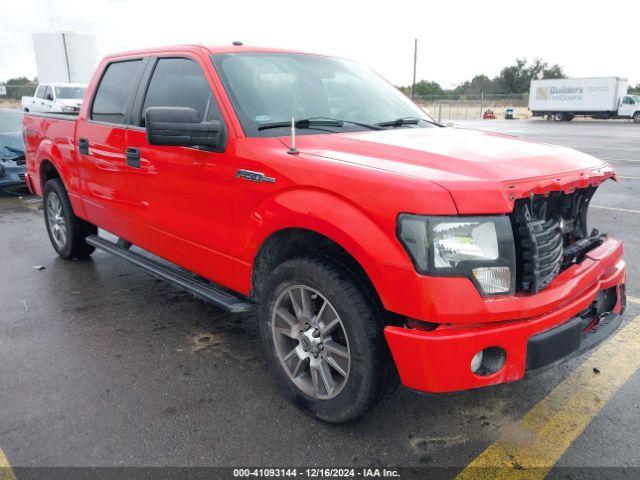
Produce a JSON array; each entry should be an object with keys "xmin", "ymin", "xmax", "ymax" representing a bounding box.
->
[{"xmin": 140, "ymin": 58, "xmax": 220, "ymax": 125}]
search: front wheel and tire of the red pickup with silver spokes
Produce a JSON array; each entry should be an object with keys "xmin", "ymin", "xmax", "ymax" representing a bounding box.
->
[{"xmin": 260, "ymin": 257, "xmax": 397, "ymax": 423}]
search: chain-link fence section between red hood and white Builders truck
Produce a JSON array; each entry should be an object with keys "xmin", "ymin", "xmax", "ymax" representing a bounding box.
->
[{"xmin": 413, "ymin": 93, "xmax": 531, "ymax": 122}]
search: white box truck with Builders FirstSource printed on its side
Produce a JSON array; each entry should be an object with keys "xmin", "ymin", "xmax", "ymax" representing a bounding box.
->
[{"xmin": 529, "ymin": 77, "xmax": 640, "ymax": 123}]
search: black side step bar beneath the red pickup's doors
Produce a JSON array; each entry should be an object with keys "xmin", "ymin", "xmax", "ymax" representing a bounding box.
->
[{"xmin": 86, "ymin": 235, "xmax": 252, "ymax": 313}]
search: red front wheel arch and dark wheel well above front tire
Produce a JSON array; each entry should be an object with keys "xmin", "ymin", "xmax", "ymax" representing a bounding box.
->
[{"xmin": 249, "ymin": 189, "xmax": 411, "ymax": 318}]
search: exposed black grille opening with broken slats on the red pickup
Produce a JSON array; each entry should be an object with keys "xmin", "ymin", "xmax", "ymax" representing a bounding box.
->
[{"xmin": 511, "ymin": 187, "xmax": 605, "ymax": 293}]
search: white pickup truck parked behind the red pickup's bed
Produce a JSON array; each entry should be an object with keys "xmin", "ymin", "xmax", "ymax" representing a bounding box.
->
[{"xmin": 22, "ymin": 83, "xmax": 87, "ymax": 113}]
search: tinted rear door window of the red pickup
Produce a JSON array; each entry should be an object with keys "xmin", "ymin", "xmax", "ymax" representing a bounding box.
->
[{"xmin": 91, "ymin": 59, "xmax": 143, "ymax": 124}]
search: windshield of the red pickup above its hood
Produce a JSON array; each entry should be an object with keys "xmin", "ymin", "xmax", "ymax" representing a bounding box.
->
[{"xmin": 212, "ymin": 52, "xmax": 432, "ymax": 137}]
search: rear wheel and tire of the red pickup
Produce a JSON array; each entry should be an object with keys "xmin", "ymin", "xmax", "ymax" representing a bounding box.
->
[{"xmin": 43, "ymin": 178, "xmax": 98, "ymax": 259}]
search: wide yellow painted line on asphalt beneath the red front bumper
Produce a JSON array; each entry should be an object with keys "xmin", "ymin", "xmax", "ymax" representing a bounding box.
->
[{"xmin": 456, "ymin": 317, "xmax": 640, "ymax": 480}]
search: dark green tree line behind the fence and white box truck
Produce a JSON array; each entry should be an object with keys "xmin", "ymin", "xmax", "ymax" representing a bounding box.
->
[{"xmin": 400, "ymin": 58, "xmax": 640, "ymax": 97}]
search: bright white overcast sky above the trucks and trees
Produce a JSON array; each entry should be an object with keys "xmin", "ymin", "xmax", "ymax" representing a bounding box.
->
[{"xmin": 0, "ymin": 0, "xmax": 640, "ymax": 88}]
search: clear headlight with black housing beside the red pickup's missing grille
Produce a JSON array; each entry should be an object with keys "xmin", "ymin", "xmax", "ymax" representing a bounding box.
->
[{"xmin": 398, "ymin": 214, "xmax": 515, "ymax": 295}]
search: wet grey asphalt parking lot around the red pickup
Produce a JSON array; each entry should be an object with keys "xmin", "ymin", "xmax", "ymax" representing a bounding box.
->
[{"xmin": 0, "ymin": 120, "xmax": 640, "ymax": 478}]
